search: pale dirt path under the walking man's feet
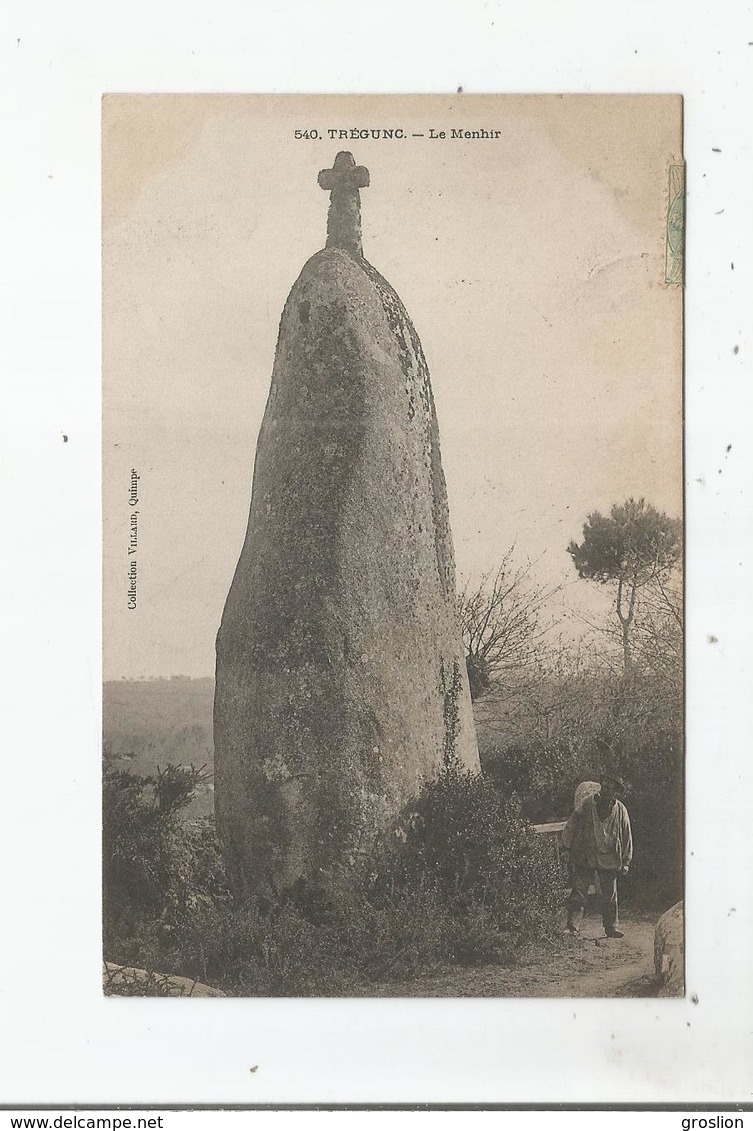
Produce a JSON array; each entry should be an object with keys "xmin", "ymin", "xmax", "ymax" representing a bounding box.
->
[{"xmin": 355, "ymin": 914, "xmax": 656, "ymax": 998}]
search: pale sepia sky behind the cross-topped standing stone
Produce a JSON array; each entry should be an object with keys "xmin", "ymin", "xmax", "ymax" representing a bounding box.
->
[{"xmin": 103, "ymin": 95, "xmax": 682, "ymax": 679}]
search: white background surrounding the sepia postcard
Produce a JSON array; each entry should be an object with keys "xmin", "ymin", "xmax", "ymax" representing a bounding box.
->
[{"xmin": 0, "ymin": 0, "xmax": 753, "ymax": 1104}]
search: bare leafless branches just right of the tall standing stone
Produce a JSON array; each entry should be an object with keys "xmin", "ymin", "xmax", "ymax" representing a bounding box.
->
[{"xmin": 458, "ymin": 545, "xmax": 560, "ymax": 699}]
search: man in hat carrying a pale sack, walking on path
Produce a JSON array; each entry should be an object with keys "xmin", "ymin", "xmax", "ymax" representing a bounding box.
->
[{"xmin": 562, "ymin": 774, "xmax": 633, "ymax": 939}]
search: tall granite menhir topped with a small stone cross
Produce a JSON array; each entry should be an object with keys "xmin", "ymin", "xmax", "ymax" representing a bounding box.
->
[{"xmin": 215, "ymin": 153, "xmax": 478, "ymax": 896}]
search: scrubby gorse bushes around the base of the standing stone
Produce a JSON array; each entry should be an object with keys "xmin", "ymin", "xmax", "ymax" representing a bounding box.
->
[{"xmin": 104, "ymin": 767, "xmax": 561, "ymax": 996}]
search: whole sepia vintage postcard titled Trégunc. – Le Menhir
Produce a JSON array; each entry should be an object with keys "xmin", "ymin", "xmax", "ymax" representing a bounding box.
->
[{"xmin": 103, "ymin": 92, "xmax": 692, "ymax": 998}]
